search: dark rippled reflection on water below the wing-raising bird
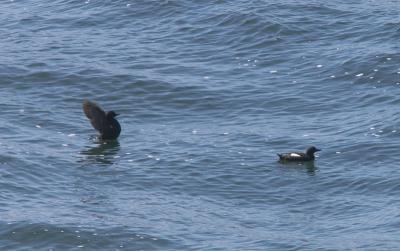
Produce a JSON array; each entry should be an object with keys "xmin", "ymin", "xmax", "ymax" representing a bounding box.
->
[{"xmin": 79, "ymin": 140, "xmax": 120, "ymax": 165}]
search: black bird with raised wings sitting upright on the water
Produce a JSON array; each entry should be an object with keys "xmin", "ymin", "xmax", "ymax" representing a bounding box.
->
[{"xmin": 83, "ymin": 100, "xmax": 121, "ymax": 139}]
